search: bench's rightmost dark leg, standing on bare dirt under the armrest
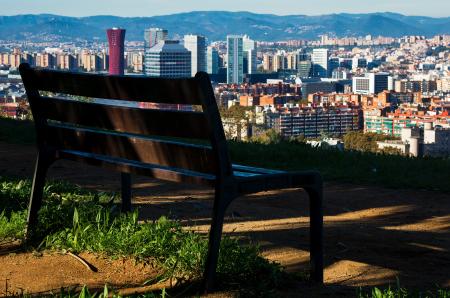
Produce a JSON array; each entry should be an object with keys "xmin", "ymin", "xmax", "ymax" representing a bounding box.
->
[{"xmin": 305, "ymin": 175, "xmax": 323, "ymax": 283}]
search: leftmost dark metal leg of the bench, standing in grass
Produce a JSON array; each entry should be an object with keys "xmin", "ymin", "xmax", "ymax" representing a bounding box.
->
[{"xmin": 25, "ymin": 152, "xmax": 53, "ymax": 240}]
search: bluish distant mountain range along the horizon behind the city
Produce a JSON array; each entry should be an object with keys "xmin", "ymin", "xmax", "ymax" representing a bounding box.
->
[{"xmin": 0, "ymin": 11, "xmax": 450, "ymax": 41}]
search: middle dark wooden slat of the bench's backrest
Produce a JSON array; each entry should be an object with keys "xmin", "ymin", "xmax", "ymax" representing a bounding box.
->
[{"xmin": 35, "ymin": 97, "xmax": 210, "ymax": 139}]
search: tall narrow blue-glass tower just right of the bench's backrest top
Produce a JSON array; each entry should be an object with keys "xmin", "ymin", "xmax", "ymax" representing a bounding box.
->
[{"xmin": 227, "ymin": 35, "xmax": 244, "ymax": 84}]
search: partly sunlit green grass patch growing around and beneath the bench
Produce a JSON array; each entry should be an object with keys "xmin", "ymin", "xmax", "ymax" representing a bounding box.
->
[{"xmin": 0, "ymin": 177, "xmax": 289, "ymax": 296}]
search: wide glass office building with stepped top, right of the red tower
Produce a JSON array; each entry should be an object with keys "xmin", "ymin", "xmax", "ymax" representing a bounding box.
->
[{"xmin": 145, "ymin": 40, "xmax": 191, "ymax": 78}]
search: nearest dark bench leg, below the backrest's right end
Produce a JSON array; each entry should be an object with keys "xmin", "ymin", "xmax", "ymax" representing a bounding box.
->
[{"xmin": 202, "ymin": 193, "xmax": 226, "ymax": 293}]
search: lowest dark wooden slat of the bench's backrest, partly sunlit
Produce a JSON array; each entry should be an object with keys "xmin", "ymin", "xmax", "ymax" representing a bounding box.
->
[{"xmin": 46, "ymin": 124, "xmax": 217, "ymax": 174}]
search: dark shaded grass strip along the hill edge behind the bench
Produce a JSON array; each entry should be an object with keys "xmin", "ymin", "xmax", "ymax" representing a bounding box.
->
[{"xmin": 0, "ymin": 117, "xmax": 450, "ymax": 192}]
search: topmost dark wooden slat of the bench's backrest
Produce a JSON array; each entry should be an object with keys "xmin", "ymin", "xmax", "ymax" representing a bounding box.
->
[{"xmin": 20, "ymin": 66, "xmax": 204, "ymax": 105}]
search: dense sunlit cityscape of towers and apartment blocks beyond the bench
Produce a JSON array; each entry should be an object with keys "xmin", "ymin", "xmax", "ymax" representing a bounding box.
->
[{"xmin": 0, "ymin": 28, "xmax": 450, "ymax": 156}]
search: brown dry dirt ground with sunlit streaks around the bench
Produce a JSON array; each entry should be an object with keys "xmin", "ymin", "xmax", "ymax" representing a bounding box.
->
[{"xmin": 0, "ymin": 143, "xmax": 450, "ymax": 297}]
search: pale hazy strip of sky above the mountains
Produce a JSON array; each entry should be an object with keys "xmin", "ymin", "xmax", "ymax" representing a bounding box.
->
[{"xmin": 0, "ymin": 0, "xmax": 450, "ymax": 17}]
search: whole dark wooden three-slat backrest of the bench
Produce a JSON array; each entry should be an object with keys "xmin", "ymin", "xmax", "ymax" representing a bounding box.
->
[{"xmin": 19, "ymin": 64, "xmax": 231, "ymax": 183}]
